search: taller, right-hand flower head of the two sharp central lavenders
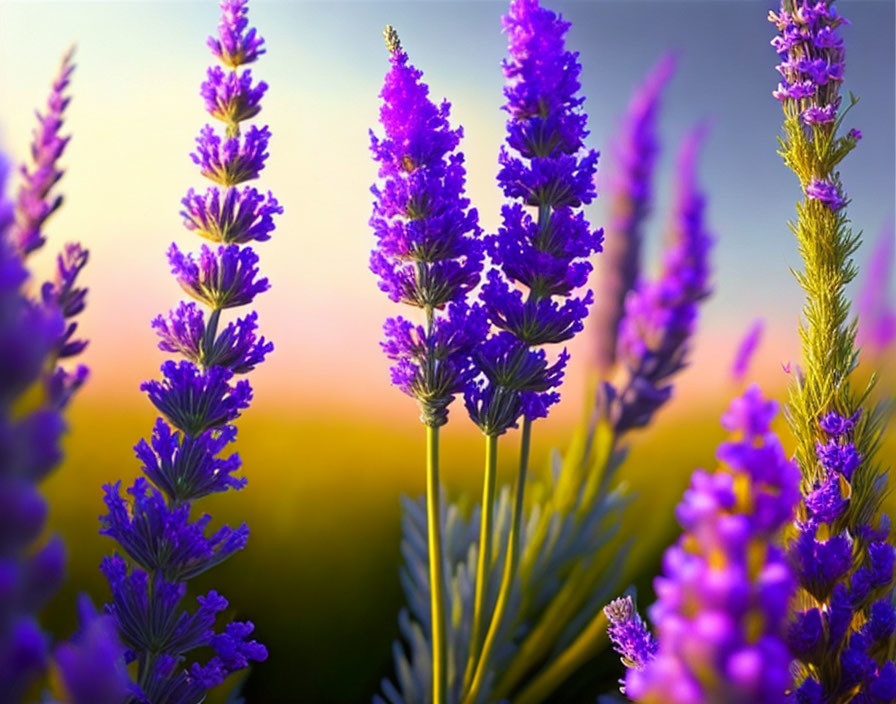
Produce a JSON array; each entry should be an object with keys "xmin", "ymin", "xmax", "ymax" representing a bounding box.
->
[{"xmin": 465, "ymin": 0, "xmax": 603, "ymax": 435}]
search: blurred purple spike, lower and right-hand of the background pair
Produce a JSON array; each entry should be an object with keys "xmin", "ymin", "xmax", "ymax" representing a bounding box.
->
[{"xmin": 602, "ymin": 128, "xmax": 712, "ymax": 433}]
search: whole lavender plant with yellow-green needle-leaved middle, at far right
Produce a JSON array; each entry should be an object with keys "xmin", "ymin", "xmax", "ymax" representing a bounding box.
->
[{"xmin": 769, "ymin": 0, "xmax": 896, "ymax": 704}]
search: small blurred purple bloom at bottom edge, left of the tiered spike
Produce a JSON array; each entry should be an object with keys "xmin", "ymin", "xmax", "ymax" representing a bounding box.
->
[{"xmin": 54, "ymin": 594, "xmax": 133, "ymax": 704}]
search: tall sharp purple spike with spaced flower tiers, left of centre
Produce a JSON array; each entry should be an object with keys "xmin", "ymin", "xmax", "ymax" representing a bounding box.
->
[{"xmin": 101, "ymin": 0, "xmax": 272, "ymax": 704}]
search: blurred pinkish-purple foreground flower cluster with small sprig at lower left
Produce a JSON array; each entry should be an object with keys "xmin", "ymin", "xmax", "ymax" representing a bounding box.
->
[{"xmin": 607, "ymin": 386, "xmax": 799, "ymax": 704}]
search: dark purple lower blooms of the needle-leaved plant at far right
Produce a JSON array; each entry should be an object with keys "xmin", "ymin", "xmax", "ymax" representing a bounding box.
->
[{"xmin": 789, "ymin": 411, "xmax": 896, "ymax": 704}]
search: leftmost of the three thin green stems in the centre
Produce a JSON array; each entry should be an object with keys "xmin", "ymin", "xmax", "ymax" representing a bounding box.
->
[{"xmin": 426, "ymin": 425, "xmax": 445, "ymax": 704}]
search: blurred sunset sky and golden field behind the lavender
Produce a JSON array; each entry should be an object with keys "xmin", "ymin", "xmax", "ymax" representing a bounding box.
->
[{"xmin": 0, "ymin": 0, "xmax": 896, "ymax": 704}]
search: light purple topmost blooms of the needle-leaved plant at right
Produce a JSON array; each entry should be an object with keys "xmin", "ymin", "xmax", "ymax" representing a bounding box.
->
[{"xmin": 768, "ymin": 0, "xmax": 847, "ymax": 129}]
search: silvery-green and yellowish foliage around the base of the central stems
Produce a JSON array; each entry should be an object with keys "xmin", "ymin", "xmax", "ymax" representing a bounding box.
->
[{"xmin": 374, "ymin": 420, "xmax": 628, "ymax": 704}]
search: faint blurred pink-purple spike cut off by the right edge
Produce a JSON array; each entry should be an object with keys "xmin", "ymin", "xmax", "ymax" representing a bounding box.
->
[{"xmin": 857, "ymin": 221, "xmax": 896, "ymax": 355}]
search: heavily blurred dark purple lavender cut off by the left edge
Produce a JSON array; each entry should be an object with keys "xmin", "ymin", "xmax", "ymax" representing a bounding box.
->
[{"xmin": 0, "ymin": 148, "xmax": 65, "ymax": 701}]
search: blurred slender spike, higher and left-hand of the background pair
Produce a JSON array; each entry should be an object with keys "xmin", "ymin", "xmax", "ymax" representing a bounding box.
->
[{"xmin": 591, "ymin": 54, "xmax": 676, "ymax": 375}]
